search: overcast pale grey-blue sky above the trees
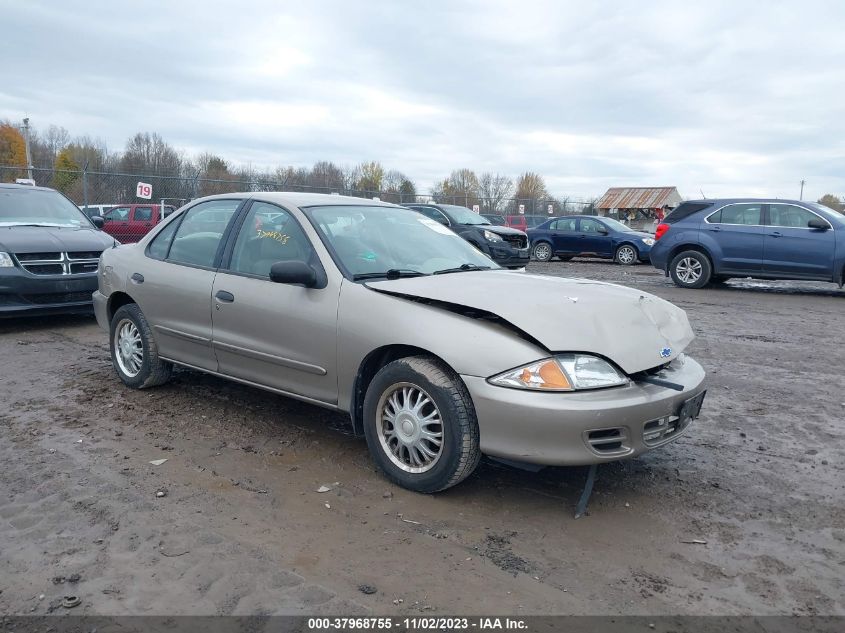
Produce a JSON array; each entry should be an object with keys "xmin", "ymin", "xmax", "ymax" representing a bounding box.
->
[{"xmin": 0, "ymin": 0, "xmax": 845, "ymax": 199}]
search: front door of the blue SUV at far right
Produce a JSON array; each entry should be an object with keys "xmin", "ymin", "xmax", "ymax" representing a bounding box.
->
[{"xmin": 763, "ymin": 203, "xmax": 836, "ymax": 280}]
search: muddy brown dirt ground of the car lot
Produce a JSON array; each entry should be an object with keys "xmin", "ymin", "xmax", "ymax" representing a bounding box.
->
[{"xmin": 0, "ymin": 261, "xmax": 845, "ymax": 615}]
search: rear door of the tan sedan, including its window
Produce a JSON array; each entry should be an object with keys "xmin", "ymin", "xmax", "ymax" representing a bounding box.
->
[{"xmin": 128, "ymin": 199, "xmax": 241, "ymax": 371}]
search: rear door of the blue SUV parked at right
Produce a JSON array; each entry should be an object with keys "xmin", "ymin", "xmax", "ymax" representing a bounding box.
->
[{"xmin": 701, "ymin": 202, "xmax": 765, "ymax": 274}]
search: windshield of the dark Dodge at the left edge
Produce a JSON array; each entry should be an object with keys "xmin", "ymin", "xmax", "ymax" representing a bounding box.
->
[{"xmin": 0, "ymin": 188, "xmax": 91, "ymax": 228}]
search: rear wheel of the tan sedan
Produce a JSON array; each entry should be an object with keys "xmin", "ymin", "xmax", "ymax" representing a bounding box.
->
[{"xmin": 109, "ymin": 303, "xmax": 173, "ymax": 389}]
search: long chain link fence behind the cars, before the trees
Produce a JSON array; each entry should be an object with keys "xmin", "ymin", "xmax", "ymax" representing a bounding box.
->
[{"xmin": 0, "ymin": 165, "xmax": 595, "ymax": 217}]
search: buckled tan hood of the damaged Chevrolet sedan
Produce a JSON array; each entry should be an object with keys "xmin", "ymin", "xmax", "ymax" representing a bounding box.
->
[{"xmin": 366, "ymin": 270, "xmax": 695, "ymax": 374}]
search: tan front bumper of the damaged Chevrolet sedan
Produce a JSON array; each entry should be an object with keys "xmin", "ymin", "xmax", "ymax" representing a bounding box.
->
[{"xmin": 462, "ymin": 357, "xmax": 704, "ymax": 466}]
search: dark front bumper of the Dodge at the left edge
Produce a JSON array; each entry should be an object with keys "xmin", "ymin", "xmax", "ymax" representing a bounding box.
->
[{"xmin": 0, "ymin": 267, "xmax": 97, "ymax": 317}]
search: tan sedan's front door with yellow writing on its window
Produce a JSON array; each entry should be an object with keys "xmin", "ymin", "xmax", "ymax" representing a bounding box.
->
[{"xmin": 212, "ymin": 202, "xmax": 340, "ymax": 404}]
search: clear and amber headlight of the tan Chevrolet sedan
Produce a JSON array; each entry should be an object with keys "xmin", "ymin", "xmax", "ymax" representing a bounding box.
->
[{"xmin": 488, "ymin": 354, "xmax": 628, "ymax": 391}]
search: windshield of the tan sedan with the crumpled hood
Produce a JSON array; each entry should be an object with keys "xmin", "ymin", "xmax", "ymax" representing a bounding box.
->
[{"xmin": 303, "ymin": 206, "xmax": 499, "ymax": 276}]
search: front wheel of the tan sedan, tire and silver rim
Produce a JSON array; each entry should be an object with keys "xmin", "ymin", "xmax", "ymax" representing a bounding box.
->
[{"xmin": 364, "ymin": 356, "xmax": 481, "ymax": 493}]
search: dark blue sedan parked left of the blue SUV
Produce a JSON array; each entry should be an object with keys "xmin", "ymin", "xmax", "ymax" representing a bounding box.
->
[{"xmin": 527, "ymin": 215, "xmax": 654, "ymax": 266}]
